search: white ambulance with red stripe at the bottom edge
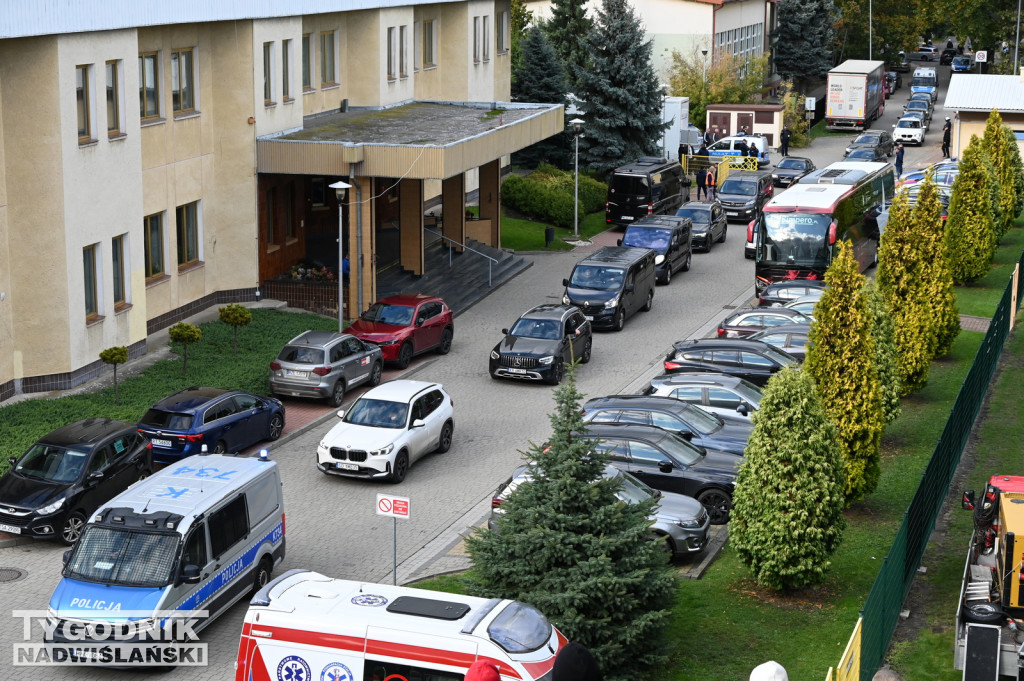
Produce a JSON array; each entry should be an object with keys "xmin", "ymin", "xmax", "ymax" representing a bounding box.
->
[{"xmin": 234, "ymin": 570, "xmax": 566, "ymax": 681}]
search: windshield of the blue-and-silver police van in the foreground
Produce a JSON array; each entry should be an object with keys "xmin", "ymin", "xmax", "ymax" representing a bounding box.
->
[{"xmin": 65, "ymin": 525, "xmax": 180, "ymax": 587}]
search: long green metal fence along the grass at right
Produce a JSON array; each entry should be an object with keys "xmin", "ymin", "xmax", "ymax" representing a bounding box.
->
[{"xmin": 860, "ymin": 253, "xmax": 1024, "ymax": 681}]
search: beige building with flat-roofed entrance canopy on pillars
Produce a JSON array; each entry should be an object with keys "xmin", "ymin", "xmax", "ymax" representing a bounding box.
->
[{"xmin": 0, "ymin": 0, "xmax": 562, "ymax": 400}]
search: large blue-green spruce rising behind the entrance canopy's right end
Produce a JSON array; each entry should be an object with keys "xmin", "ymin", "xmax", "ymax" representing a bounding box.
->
[{"xmin": 575, "ymin": 0, "xmax": 671, "ymax": 173}]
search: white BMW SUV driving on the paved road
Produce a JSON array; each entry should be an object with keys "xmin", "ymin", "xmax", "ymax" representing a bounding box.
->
[{"xmin": 316, "ymin": 380, "xmax": 455, "ymax": 482}]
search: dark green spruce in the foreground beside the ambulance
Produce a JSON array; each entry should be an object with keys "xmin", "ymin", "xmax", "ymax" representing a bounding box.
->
[{"xmin": 466, "ymin": 369, "xmax": 676, "ymax": 679}]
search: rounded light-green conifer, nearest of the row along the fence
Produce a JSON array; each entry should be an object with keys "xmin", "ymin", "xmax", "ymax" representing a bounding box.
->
[{"xmin": 729, "ymin": 369, "xmax": 846, "ymax": 589}]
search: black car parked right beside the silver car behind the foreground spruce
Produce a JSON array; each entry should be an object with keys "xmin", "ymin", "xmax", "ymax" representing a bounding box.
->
[{"xmin": 582, "ymin": 423, "xmax": 743, "ymax": 525}]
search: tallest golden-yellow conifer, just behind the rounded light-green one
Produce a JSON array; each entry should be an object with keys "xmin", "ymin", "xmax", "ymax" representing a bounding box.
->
[{"xmin": 804, "ymin": 241, "xmax": 884, "ymax": 504}]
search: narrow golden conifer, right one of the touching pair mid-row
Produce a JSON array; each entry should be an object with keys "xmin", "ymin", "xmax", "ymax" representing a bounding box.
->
[{"xmin": 913, "ymin": 175, "xmax": 959, "ymax": 358}]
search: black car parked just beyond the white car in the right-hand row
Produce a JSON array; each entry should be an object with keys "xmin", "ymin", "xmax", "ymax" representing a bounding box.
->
[{"xmin": 665, "ymin": 338, "xmax": 800, "ymax": 386}]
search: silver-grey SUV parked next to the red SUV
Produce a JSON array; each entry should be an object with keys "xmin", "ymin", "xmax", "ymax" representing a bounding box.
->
[{"xmin": 270, "ymin": 331, "xmax": 384, "ymax": 407}]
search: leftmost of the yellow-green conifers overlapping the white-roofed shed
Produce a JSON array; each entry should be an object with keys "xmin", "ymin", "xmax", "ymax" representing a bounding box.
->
[{"xmin": 942, "ymin": 135, "xmax": 995, "ymax": 284}]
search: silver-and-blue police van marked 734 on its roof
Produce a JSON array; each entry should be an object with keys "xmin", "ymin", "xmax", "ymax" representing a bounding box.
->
[{"xmin": 46, "ymin": 451, "xmax": 285, "ymax": 643}]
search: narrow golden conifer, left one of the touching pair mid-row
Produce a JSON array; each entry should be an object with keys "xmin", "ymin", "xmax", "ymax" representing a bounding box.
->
[{"xmin": 876, "ymin": 191, "xmax": 931, "ymax": 395}]
